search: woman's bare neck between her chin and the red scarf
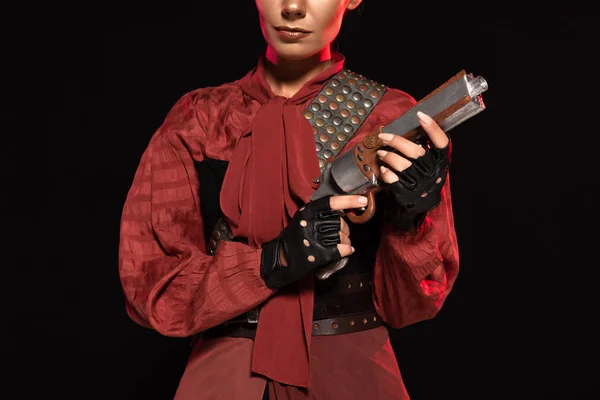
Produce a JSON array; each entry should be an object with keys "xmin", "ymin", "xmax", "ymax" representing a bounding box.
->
[{"xmin": 266, "ymin": 46, "xmax": 331, "ymax": 98}]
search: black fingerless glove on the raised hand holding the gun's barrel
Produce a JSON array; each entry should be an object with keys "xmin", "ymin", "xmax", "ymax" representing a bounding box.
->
[{"xmin": 387, "ymin": 141, "xmax": 452, "ymax": 232}]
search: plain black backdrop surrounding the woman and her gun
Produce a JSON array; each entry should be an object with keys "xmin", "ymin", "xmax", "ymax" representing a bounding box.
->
[{"xmin": 0, "ymin": 0, "xmax": 599, "ymax": 400}]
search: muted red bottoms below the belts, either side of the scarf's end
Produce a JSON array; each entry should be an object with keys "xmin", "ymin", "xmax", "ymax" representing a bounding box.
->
[{"xmin": 175, "ymin": 327, "xmax": 409, "ymax": 400}]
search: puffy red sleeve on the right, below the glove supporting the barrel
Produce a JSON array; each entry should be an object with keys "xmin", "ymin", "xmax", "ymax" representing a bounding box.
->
[{"xmin": 373, "ymin": 177, "xmax": 459, "ymax": 328}]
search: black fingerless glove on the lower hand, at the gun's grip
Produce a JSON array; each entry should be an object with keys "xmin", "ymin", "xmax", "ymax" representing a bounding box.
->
[{"xmin": 260, "ymin": 196, "xmax": 341, "ymax": 289}]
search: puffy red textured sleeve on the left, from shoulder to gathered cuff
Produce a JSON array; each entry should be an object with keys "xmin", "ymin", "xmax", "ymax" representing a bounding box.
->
[{"xmin": 119, "ymin": 91, "xmax": 272, "ymax": 337}]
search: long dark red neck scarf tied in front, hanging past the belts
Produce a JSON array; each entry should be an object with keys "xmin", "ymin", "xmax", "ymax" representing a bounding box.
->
[{"xmin": 221, "ymin": 53, "xmax": 344, "ymax": 387}]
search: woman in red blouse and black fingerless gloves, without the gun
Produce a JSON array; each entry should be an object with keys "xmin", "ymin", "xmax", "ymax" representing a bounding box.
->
[{"xmin": 119, "ymin": 0, "xmax": 458, "ymax": 400}]
